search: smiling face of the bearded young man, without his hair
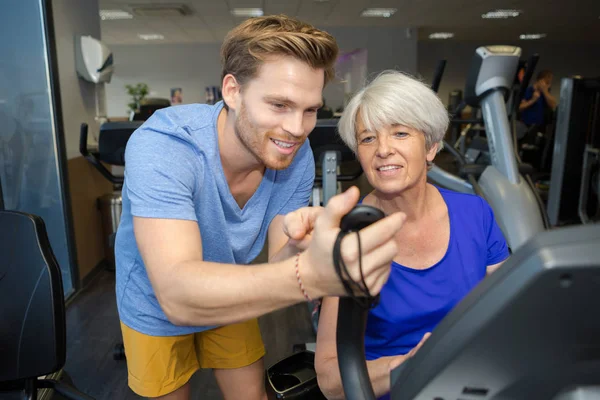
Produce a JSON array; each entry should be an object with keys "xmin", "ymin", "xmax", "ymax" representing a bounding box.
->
[{"xmin": 235, "ymin": 57, "xmax": 325, "ymax": 169}]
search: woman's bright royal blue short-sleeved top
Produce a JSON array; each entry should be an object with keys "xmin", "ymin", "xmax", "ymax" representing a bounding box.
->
[{"xmin": 365, "ymin": 188, "xmax": 509, "ymax": 400}]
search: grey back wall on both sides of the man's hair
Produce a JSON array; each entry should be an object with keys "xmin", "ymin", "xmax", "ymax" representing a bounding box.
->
[{"xmin": 106, "ymin": 28, "xmax": 417, "ymax": 117}]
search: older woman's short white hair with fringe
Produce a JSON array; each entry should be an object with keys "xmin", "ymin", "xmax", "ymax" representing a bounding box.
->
[{"xmin": 338, "ymin": 70, "xmax": 449, "ymax": 152}]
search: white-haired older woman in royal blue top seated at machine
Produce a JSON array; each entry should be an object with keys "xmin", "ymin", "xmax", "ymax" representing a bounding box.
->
[{"xmin": 316, "ymin": 71, "xmax": 509, "ymax": 400}]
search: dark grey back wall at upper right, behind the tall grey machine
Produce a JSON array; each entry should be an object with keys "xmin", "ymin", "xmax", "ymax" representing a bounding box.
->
[{"xmin": 418, "ymin": 41, "xmax": 600, "ymax": 108}]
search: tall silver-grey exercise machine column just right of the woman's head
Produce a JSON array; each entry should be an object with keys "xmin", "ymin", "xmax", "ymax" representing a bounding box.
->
[{"xmin": 428, "ymin": 46, "xmax": 549, "ymax": 251}]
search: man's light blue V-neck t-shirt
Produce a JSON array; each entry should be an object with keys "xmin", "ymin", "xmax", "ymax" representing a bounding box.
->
[{"xmin": 115, "ymin": 102, "xmax": 315, "ymax": 336}]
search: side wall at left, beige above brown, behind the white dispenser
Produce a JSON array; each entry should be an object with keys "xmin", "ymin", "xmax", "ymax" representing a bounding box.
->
[{"xmin": 52, "ymin": 0, "xmax": 111, "ymax": 281}]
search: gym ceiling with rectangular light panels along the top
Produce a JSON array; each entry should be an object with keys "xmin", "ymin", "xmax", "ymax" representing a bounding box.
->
[{"xmin": 100, "ymin": 0, "xmax": 600, "ymax": 45}]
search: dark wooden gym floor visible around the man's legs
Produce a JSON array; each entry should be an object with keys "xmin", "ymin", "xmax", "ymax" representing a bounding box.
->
[{"xmin": 64, "ymin": 264, "xmax": 315, "ymax": 400}]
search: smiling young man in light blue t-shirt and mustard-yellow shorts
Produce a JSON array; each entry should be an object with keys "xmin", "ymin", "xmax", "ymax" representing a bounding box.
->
[{"xmin": 115, "ymin": 16, "xmax": 404, "ymax": 400}]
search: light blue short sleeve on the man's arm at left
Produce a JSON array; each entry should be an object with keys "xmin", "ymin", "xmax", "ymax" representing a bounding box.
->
[{"xmin": 123, "ymin": 126, "xmax": 203, "ymax": 221}]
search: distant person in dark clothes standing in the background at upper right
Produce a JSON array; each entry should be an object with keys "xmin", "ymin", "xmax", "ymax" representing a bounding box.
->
[{"xmin": 519, "ymin": 70, "xmax": 557, "ymax": 130}]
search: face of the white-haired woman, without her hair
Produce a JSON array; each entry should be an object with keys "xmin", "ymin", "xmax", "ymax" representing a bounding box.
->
[{"xmin": 356, "ymin": 116, "xmax": 437, "ymax": 194}]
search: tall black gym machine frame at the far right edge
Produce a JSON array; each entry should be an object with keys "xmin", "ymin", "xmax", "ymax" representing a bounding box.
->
[{"xmin": 548, "ymin": 77, "xmax": 600, "ymax": 225}]
